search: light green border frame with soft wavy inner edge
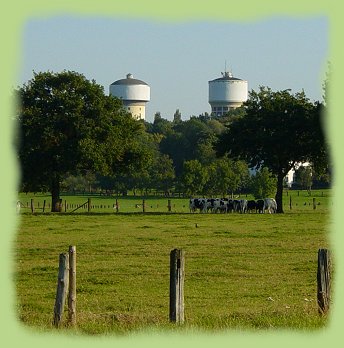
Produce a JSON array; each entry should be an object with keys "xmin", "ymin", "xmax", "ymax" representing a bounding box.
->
[{"xmin": 0, "ymin": 0, "xmax": 344, "ymax": 348}]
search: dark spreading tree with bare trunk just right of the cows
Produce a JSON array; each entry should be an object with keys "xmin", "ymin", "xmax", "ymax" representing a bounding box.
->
[{"xmin": 217, "ymin": 87, "xmax": 327, "ymax": 213}]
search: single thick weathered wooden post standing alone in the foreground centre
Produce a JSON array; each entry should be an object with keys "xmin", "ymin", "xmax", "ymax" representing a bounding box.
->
[{"xmin": 170, "ymin": 249, "xmax": 185, "ymax": 324}]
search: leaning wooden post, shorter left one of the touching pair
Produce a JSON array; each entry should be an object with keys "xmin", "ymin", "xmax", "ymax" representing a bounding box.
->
[{"xmin": 53, "ymin": 254, "xmax": 69, "ymax": 327}]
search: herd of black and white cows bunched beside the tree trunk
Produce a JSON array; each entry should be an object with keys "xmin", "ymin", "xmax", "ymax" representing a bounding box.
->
[{"xmin": 189, "ymin": 198, "xmax": 277, "ymax": 214}]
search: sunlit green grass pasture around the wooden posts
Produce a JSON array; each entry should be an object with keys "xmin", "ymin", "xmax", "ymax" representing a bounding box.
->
[{"xmin": 13, "ymin": 191, "xmax": 331, "ymax": 334}]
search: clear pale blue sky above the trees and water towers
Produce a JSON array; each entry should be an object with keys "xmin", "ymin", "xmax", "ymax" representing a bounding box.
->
[{"xmin": 17, "ymin": 15, "xmax": 329, "ymax": 122}]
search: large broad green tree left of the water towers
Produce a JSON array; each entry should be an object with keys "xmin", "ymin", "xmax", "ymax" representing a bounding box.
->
[{"xmin": 17, "ymin": 71, "xmax": 144, "ymax": 211}]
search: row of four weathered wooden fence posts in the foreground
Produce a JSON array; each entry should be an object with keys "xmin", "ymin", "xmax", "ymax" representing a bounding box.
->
[{"xmin": 53, "ymin": 246, "xmax": 331, "ymax": 328}]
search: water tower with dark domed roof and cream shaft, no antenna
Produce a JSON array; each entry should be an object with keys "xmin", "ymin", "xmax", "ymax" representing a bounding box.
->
[{"xmin": 110, "ymin": 74, "xmax": 150, "ymax": 120}]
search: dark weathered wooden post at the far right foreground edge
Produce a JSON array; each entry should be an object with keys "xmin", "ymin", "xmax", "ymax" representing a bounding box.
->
[{"xmin": 317, "ymin": 249, "xmax": 331, "ymax": 315}]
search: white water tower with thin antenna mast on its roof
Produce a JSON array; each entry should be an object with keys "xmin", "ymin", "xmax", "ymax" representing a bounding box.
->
[{"xmin": 208, "ymin": 71, "xmax": 248, "ymax": 116}]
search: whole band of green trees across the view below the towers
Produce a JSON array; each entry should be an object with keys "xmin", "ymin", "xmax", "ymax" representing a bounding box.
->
[{"xmin": 16, "ymin": 71, "xmax": 331, "ymax": 212}]
